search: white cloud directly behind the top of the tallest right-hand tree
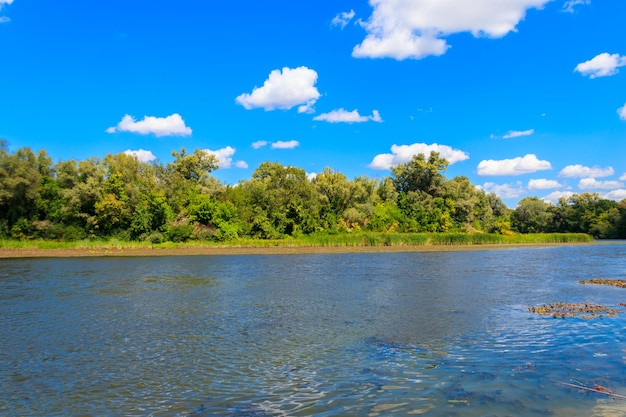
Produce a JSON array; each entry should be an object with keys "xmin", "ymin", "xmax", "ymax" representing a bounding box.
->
[{"xmin": 368, "ymin": 143, "xmax": 469, "ymax": 169}]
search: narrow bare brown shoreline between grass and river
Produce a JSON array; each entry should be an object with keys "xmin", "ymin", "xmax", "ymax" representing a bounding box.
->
[{"xmin": 0, "ymin": 241, "xmax": 614, "ymax": 259}]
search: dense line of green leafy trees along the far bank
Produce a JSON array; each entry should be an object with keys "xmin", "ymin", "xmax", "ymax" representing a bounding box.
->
[{"xmin": 0, "ymin": 141, "xmax": 626, "ymax": 243}]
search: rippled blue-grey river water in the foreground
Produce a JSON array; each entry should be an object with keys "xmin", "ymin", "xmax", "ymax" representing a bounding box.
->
[{"xmin": 0, "ymin": 244, "xmax": 626, "ymax": 416}]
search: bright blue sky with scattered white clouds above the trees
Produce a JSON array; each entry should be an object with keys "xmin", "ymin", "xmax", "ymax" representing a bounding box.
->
[{"xmin": 0, "ymin": 0, "xmax": 626, "ymax": 207}]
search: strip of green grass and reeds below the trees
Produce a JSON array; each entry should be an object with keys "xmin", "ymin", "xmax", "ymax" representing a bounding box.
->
[{"xmin": 0, "ymin": 232, "xmax": 593, "ymax": 250}]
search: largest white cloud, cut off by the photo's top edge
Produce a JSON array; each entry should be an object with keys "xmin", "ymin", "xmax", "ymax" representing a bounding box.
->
[{"xmin": 352, "ymin": 0, "xmax": 550, "ymax": 60}]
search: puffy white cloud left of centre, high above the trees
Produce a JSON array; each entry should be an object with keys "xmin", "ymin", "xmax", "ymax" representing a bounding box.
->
[{"xmin": 235, "ymin": 67, "xmax": 320, "ymax": 113}]
